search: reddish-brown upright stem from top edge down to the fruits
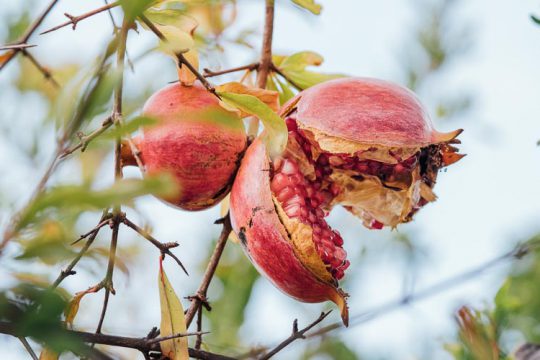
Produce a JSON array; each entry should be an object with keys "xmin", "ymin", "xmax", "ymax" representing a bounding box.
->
[{"xmin": 248, "ymin": 0, "xmax": 275, "ymax": 137}]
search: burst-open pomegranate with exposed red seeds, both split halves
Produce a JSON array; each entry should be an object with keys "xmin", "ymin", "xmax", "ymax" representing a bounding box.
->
[{"xmin": 230, "ymin": 78, "xmax": 463, "ymax": 324}]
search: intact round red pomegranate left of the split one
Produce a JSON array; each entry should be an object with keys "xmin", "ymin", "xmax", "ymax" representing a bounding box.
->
[{"xmin": 122, "ymin": 84, "xmax": 247, "ymax": 210}]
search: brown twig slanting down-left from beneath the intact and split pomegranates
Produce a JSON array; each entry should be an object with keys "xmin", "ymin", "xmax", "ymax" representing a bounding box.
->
[{"xmin": 186, "ymin": 214, "xmax": 231, "ymax": 327}]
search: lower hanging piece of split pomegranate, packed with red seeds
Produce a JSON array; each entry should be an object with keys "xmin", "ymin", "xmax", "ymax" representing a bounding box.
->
[{"xmin": 230, "ymin": 137, "xmax": 349, "ymax": 324}]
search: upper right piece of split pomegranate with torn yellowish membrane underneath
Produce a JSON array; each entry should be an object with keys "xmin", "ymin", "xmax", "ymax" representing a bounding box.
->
[{"xmin": 282, "ymin": 78, "xmax": 464, "ymax": 229}]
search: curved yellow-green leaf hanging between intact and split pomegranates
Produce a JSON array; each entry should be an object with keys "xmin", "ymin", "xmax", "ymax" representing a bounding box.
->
[{"xmin": 218, "ymin": 92, "xmax": 288, "ymax": 158}]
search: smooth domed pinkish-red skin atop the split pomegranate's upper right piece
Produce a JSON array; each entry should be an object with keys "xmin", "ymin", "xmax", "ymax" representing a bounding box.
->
[{"xmin": 283, "ymin": 78, "xmax": 461, "ymax": 148}]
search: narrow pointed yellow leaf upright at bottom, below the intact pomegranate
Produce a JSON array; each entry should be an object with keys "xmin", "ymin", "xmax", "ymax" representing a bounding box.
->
[{"xmin": 158, "ymin": 260, "xmax": 189, "ymax": 360}]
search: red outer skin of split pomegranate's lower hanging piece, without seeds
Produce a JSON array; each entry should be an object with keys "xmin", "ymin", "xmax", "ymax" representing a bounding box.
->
[{"xmin": 230, "ymin": 138, "xmax": 348, "ymax": 325}]
